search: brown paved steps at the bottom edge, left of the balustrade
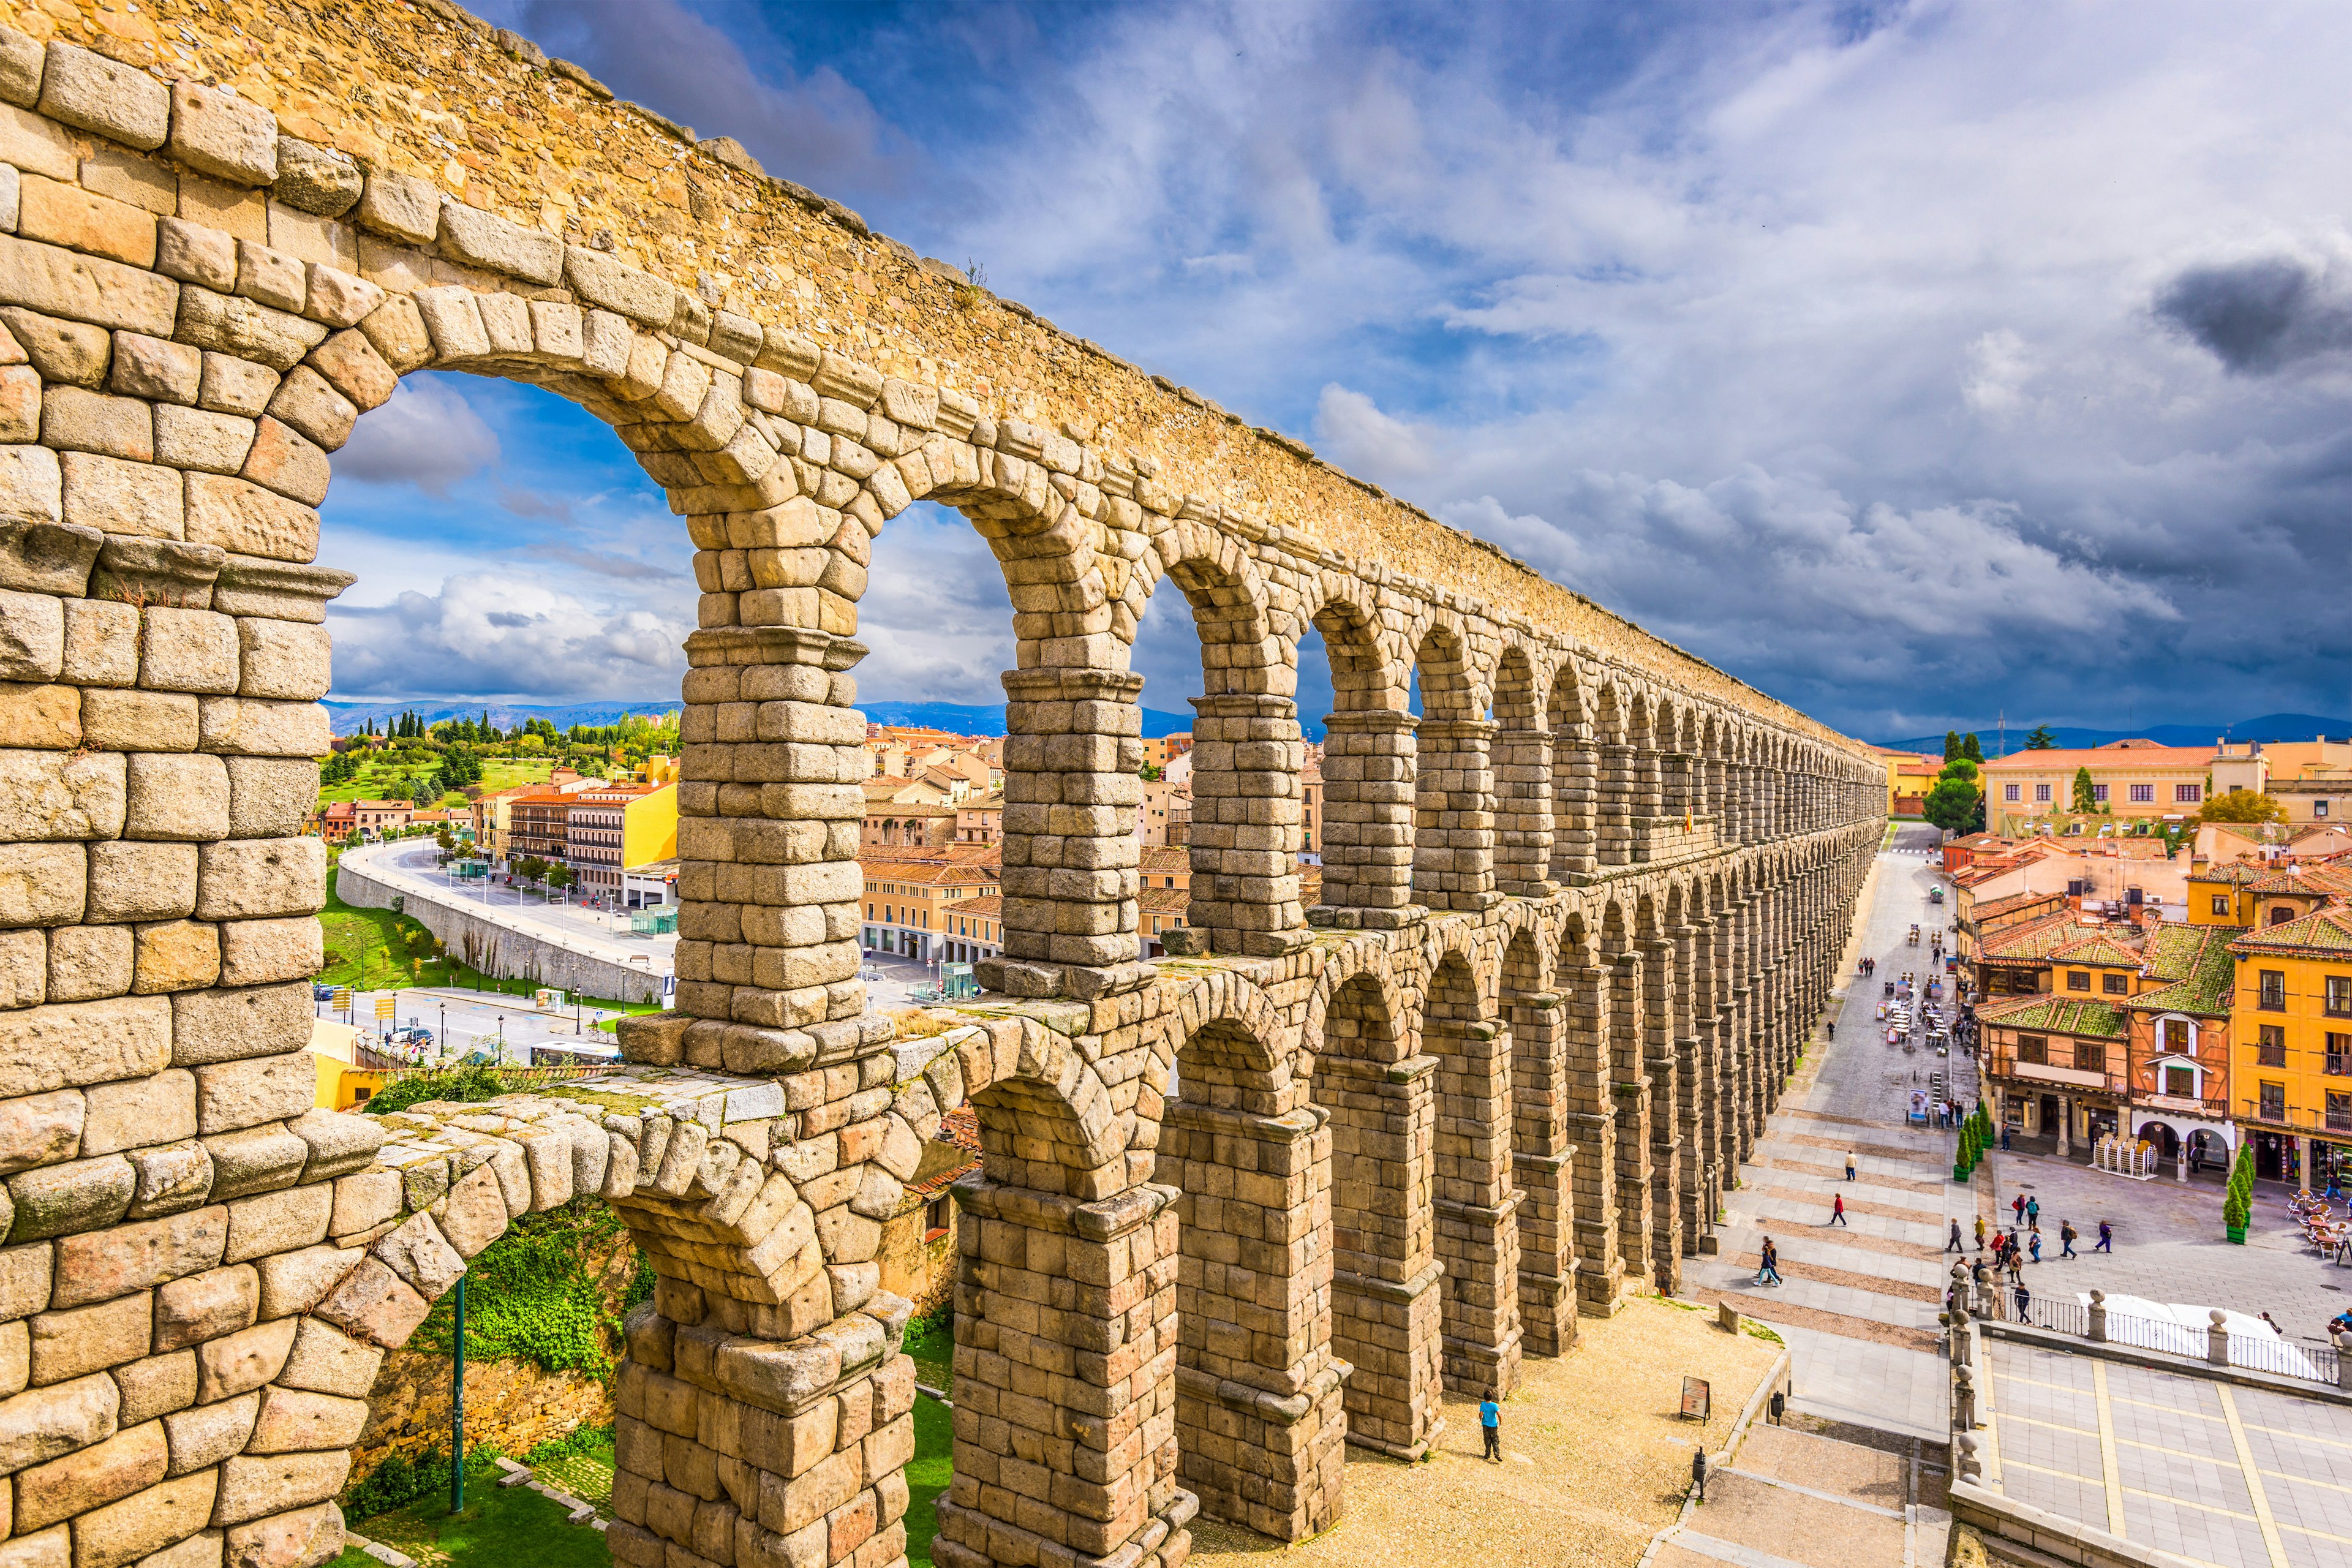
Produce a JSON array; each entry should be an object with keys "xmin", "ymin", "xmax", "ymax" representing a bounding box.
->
[{"xmin": 1642, "ymin": 1413, "xmax": 1952, "ymax": 1568}]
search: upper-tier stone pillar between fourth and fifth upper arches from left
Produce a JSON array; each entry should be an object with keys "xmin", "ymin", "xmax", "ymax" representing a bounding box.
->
[{"xmin": 1308, "ymin": 707, "xmax": 1428, "ymax": 931}]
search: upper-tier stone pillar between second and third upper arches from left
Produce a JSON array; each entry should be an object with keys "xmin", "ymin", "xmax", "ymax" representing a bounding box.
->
[{"xmin": 978, "ymin": 670, "xmax": 1155, "ymax": 999}]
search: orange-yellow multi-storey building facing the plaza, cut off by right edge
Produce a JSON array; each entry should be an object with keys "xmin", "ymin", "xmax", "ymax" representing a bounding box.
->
[{"xmin": 2230, "ymin": 895, "xmax": 2352, "ymax": 1187}]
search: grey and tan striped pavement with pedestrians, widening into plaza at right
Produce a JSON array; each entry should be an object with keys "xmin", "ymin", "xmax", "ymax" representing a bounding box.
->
[{"xmin": 1689, "ymin": 827, "xmax": 2352, "ymax": 1436}]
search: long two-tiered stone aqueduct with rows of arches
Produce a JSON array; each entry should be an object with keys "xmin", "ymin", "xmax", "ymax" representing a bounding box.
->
[{"xmin": 0, "ymin": 12, "xmax": 1884, "ymax": 1568}]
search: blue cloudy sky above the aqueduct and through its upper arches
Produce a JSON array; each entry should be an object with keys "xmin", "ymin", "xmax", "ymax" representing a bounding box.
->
[{"xmin": 322, "ymin": 0, "xmax": 2352, "ymax": 738}]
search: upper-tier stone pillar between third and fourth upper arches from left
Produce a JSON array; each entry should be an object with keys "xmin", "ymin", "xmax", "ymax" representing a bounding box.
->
[{"xmin": 1185, "ymin": 693, "xmax": 1310, "ymax": 959}]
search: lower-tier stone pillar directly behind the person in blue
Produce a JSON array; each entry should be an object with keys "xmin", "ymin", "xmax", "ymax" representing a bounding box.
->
[{"xmin": 1423, "ymin": 1011, "xmax": 1520, "ymax": 1394}]
